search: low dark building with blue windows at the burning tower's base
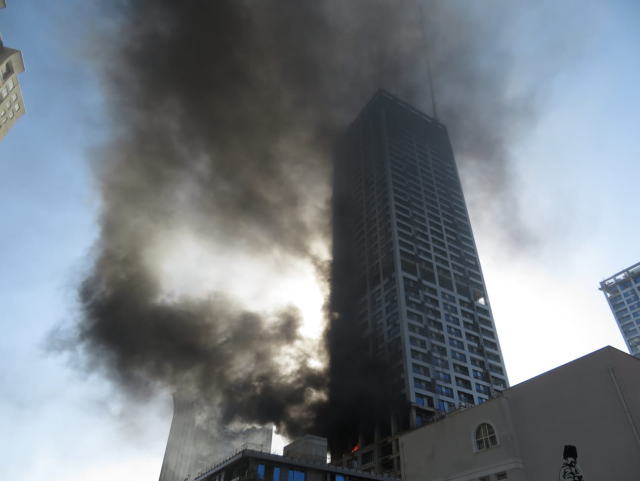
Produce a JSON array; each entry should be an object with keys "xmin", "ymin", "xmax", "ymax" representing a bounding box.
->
[{"xmin": 192, "ymin": 436, "xmax": 398, "ymax": 481}]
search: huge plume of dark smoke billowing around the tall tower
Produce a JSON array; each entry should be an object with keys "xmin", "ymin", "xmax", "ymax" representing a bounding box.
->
[{"xmin": 61, "ymin": 0, "xmax": 560, "ymax": 450}]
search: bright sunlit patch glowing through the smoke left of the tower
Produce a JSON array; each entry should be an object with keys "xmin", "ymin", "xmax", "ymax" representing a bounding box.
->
[{"xmin": 150, "ymin": 231, "xmax": 326, "ymax": 340}]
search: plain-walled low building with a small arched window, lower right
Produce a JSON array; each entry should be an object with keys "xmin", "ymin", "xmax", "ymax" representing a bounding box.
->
[{"xmin": 400, "ymin": 347, "xmax": 640, "ymax": 481}]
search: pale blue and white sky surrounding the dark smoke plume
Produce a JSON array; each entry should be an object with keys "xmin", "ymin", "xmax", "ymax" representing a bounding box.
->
[{"xmin": 0, "ymin": 0, "xmax": 640, "ymax": 481}]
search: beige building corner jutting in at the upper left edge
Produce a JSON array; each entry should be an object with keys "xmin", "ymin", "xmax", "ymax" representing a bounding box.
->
[{"xmin": 0, "ymin": 0, "xmax": 25, "ymax": 142}]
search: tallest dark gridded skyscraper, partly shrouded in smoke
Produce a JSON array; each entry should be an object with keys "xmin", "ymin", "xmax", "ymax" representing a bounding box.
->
[{"xmin": 332, "ymin": 90, "xmax": 509, "ymax": 472}]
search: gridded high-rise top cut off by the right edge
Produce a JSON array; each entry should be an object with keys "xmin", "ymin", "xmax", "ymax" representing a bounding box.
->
[{"xmin": 600, "ymin": 262, "xmax": 640, "ymax": 358}]
